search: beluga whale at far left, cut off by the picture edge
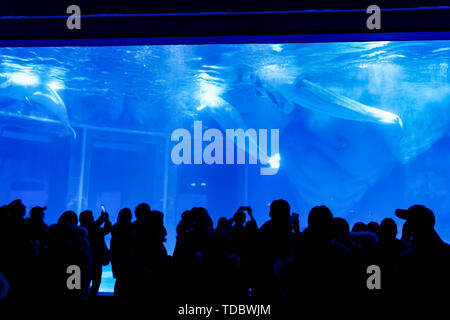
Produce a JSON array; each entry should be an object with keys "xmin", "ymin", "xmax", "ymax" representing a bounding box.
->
[{"xmin": 0, "ymin": 72, "xmax": 77, "ymax": 139}]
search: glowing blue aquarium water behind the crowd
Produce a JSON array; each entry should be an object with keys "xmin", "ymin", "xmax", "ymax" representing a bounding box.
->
[{"xmin": 0, "ymin": 41, "xmax": 450, "ymax": 291}]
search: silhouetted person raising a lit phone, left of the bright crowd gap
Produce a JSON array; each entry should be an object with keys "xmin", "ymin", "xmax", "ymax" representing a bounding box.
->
[{"xmin": 80, "ymin": 210, "xmax": 111, "ymax": 296}]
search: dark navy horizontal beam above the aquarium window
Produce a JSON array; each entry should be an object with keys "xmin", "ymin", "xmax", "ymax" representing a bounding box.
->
[{"xmin": 0, "ymin": 7, "xmax": 450, "ymax": 43}]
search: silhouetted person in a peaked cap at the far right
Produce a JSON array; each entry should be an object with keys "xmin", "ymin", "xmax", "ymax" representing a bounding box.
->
[{"xmin": 395, "ymin": 205, "xmax": 450, "ymax": 297}]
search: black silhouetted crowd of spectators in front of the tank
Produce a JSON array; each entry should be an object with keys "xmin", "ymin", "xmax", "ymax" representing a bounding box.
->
[{"xmin": 0, "ymin": 199, "xmax": 450, "ymax": 308}]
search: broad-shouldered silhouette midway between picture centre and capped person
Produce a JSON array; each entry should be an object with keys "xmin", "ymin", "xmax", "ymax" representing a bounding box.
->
[{"xmin": 276, "ymin": 206, "xmax": 357, "ymax": 311}]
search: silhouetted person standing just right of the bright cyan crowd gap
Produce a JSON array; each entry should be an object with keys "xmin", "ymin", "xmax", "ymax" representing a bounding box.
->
[{"xmin": 111, "ymin": 208, "xmax": 133, "ymax": 296}]
